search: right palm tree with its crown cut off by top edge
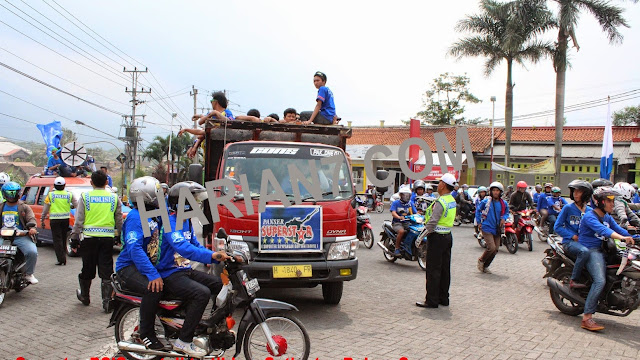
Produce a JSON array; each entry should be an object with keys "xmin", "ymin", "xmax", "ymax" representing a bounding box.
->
[{"xmin": 553, "ymin": 0, "xmax": 637, "ymax": 180}]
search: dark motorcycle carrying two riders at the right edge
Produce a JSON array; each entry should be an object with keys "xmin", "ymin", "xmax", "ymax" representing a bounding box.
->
[{"xmin": 542, "ymin": 236, "xmax": 640, "ymax": 316}]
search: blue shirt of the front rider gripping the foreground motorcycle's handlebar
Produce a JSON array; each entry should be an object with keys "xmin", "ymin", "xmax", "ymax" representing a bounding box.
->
[{"xmin": 156, "ymin": 213, "xmax": 218, "ymax": 279}]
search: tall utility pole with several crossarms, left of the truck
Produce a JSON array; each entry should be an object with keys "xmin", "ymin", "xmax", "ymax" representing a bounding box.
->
[{"xmin": 120, "ymin": 67, "xmax": 151, "ymax": 187}]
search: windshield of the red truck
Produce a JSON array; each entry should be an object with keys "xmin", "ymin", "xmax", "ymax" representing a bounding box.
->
[{"xmin": 223, "ymin": 143, "xmax": 353, "ymax": 201}]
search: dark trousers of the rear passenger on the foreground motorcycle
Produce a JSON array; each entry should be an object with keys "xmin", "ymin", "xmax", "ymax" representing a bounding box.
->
[{"xmin": 118, "ymin": 265, "xmax": 162, "ymax": 338}]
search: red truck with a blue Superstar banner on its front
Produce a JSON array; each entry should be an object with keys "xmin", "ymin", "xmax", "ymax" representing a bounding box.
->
[{"xmin": 203, "ymin": 122, "xmax": 358, "ymax": 304}]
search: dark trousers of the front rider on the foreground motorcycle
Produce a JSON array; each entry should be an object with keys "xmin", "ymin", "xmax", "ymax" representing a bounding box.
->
[{"xmin": 163, "ymin": 269, "xmax": 222, "ymax": 342}]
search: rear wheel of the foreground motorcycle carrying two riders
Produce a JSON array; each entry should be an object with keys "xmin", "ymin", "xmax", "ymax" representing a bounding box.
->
[{"xmin": 114, "ymin": 306, "xmax": 166, "ymax": 360}]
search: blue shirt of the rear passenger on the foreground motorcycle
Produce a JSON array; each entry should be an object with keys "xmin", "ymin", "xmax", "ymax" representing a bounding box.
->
[{"xmin": 116, "ymin": 209, "xmax": 162, "ymax": 281}]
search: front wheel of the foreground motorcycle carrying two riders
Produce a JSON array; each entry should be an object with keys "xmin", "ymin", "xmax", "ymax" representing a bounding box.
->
[{"xmin": 243, "ymin": 314, "xmax": 311, "ymax": 360}]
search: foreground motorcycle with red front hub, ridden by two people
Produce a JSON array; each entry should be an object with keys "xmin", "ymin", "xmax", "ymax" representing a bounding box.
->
[{"xmin": 109, "ymin": 229, "xmax": 310, "ymax": 360}]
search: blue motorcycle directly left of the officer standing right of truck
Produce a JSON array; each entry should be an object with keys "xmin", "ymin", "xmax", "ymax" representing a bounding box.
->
[{"xmin": 378, "ymin": 214, "xmax": 427, "ymax": 271}]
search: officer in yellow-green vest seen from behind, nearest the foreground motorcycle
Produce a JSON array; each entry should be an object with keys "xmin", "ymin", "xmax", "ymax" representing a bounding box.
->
[{"xmin": 71, "ymin": 170, "xmax": 122, "ymax": 312}]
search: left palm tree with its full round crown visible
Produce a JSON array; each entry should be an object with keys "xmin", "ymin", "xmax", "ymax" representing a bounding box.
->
[{"xmin": 449, "ymin": 0, "xmax": 555, "ymax": 172}]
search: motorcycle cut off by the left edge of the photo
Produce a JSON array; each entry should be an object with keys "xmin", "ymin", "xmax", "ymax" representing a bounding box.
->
[{"xmin": 0, "ymin": 223, "xmax": 35, "ymax": 305}]
